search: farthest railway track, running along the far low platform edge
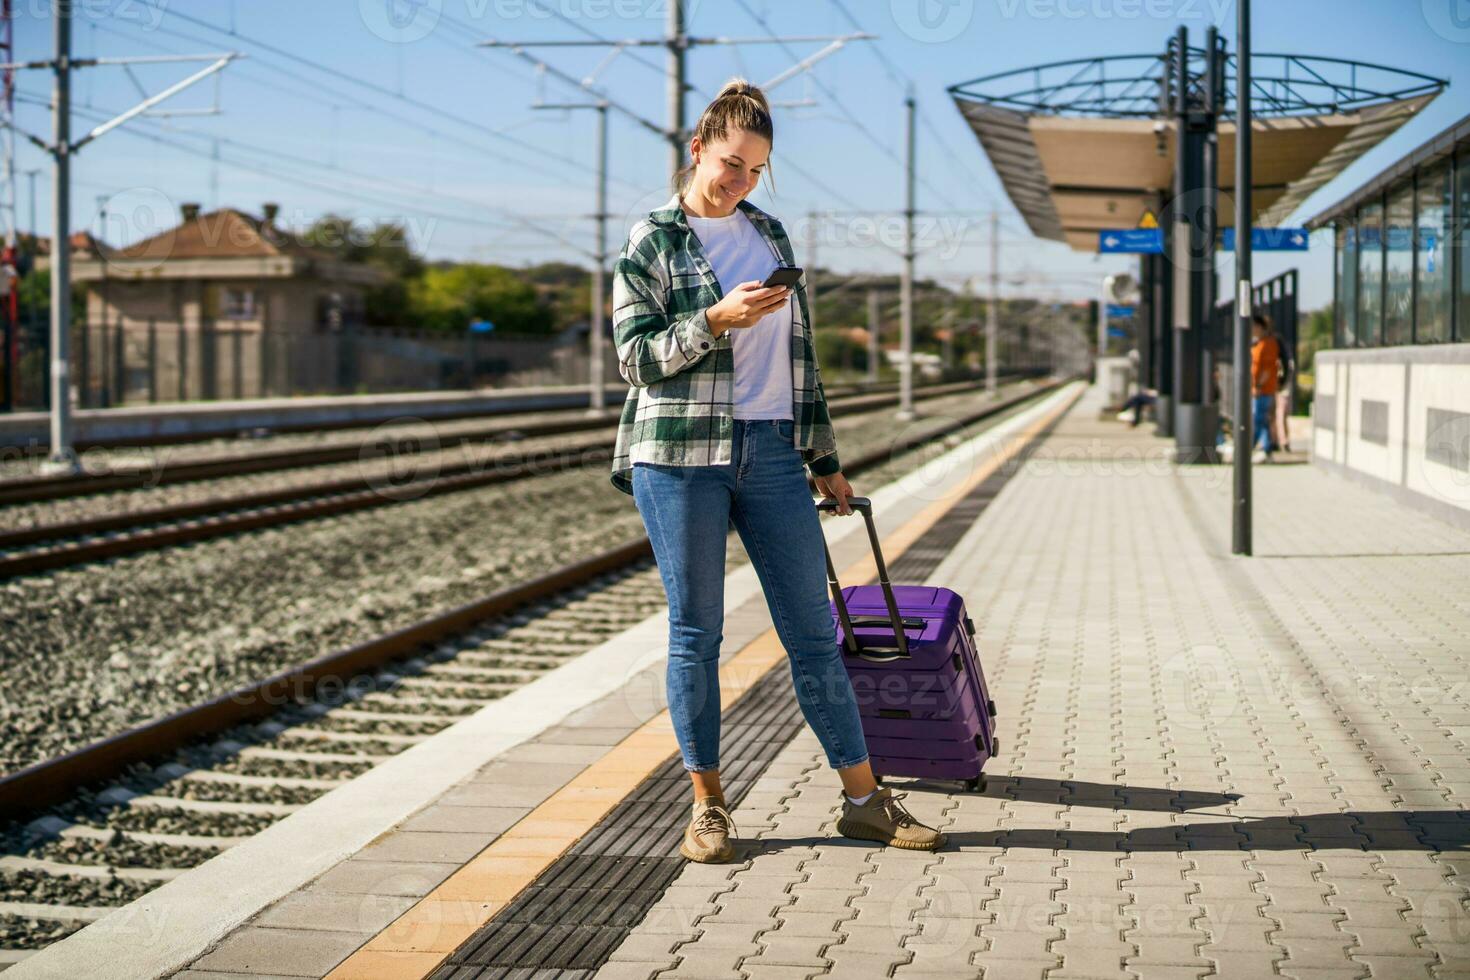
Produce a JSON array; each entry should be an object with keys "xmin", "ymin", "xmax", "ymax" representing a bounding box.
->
[{"xmin": 0, "ymin": 381, "xmax": 1005, "ymax": 507}]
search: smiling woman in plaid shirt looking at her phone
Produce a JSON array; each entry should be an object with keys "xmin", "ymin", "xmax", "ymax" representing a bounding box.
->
[{"xmin": 612, "ymin": 78, "xmax": 944, "ymax": 862}]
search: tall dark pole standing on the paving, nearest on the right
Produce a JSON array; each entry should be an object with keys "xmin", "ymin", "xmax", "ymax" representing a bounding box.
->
[{"xmin": 1230, "ymin": 0, "xmax": 1255, "ymax": 555}]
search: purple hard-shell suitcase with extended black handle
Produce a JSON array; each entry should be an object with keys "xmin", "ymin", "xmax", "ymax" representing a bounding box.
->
[{"xmin": 817, "ymin": 497, "xmax": 995, "ymax": 790}]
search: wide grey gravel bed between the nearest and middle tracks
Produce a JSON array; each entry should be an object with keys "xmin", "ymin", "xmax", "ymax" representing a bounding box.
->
[{"xmin": 0, "ymin": 382, "xmax": 1034, "ymax": 773}]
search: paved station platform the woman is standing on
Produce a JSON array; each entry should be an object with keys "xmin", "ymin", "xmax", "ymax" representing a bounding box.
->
[{"xmin": 14, "ymin": 385, "xmax": 1470, "ymax": 980}]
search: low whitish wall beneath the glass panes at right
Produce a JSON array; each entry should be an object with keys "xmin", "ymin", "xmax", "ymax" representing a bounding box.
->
[{"xmin": 1311, "ymin": 344, "xmax": 1470, "ymax": 526}]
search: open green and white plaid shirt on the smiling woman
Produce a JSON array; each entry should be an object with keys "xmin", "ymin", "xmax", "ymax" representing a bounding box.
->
[{"xmin": 612, "ymin": 194, "xmax": 841, "ymax": 494}]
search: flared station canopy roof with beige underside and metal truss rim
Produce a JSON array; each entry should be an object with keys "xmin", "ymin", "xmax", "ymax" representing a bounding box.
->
[{"xmin": 950, "ymin": 48, "xmax": 1445, "ymax": 251}]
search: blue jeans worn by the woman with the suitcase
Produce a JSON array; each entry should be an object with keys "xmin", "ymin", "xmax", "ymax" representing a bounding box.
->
[{"xmin": 632, "ymin": 419, "xmax": 867, "ymax": 771}]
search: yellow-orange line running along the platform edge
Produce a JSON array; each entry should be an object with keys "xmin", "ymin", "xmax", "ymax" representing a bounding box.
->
[{"xmin": 326, "ymin": 389, "xmax": 1080, "ymax": 980}]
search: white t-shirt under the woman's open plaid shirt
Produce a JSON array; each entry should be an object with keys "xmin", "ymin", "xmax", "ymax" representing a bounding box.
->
[{"xmin": 685, "ymin": 209, "xmax": 795, "ymax": 419}]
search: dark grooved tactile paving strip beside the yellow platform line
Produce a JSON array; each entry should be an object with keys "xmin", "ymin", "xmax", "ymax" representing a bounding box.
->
[{"xmin": 431, "ymin": 419, "xmax": 1060, "ymax": 980}]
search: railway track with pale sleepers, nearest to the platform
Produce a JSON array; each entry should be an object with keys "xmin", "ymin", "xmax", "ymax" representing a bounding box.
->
[{"xmin": 0, "ymin": 385, "xmax": 1055, "ymax": 968}]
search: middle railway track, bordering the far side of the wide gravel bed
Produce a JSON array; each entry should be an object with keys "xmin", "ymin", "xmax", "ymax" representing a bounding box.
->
[{"xmin": 0, "ymin": 382, "xmax": 1023, "ymax": 579}]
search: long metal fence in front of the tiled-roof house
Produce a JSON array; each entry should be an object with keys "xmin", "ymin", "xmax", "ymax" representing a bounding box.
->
[{"xmin": 1, "ymin": 320, "xmax": 622, "ymax": 411}]
